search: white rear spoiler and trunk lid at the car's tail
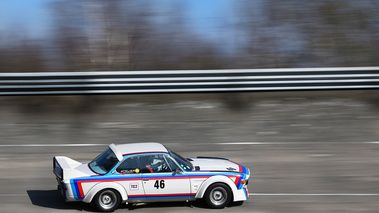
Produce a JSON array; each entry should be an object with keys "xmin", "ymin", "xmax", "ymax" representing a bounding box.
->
[{"xmin": 54, "ymin": 156, "xmax": 97, "ymax": 180}]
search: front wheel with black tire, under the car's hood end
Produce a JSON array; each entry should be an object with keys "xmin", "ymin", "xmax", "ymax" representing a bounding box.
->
[{"xmin": 204, "ymin": 183, "xmax": 233, "ymax": 209}]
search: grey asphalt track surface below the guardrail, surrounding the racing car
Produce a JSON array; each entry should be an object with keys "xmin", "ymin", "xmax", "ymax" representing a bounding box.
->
[{"xmin": 0, "ymin": 94, "xmax": 379, "ymax": 213}]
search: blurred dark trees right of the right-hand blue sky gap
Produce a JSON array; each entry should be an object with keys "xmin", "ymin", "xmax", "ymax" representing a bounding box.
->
[{"xmin": 239, "ymin": 0, "xmax": 379, "ymax": 67}]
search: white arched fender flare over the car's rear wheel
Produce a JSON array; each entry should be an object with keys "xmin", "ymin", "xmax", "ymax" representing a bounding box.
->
[{"xmin": 83, "ymin": 182, "xmax": 128, "ymax": 203}]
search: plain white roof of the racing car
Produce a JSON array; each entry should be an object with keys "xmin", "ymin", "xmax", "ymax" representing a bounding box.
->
[{"xmin": 111, "ymin": 142, "xmax": 168, "ymax": 155}]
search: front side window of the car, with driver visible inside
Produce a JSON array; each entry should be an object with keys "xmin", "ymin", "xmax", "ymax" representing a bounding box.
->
[{"xmin": 140, "ymin": 155, "xmax": 171, "ymax": 173}]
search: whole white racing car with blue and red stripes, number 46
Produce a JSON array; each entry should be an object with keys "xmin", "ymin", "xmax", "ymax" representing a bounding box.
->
[{"xmin": 53, "ymin": 143, "xmax": 250, "ymax": 211}]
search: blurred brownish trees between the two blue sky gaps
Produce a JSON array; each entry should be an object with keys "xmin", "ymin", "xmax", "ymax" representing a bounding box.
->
[{"xmin": 53, "ymin": 0, "xmax": 229, "ymax": 71}]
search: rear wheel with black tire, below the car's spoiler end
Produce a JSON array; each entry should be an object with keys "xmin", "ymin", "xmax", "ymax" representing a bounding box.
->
[{"xmin": 92, "ymin": 189, "xmax": 121, "ymax": 212}]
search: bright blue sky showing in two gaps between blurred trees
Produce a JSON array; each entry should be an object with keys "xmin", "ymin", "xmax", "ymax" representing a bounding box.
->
[{"xmin": 0, "ymin": 0, "xmax": 233, "ymax": 42}]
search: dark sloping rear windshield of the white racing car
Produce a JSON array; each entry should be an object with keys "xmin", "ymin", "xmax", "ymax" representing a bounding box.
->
[{"xmin": 88, "ymin": 149, "xmax": 118, "ymax": 175}]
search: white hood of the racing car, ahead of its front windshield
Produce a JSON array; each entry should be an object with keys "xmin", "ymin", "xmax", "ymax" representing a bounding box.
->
[{"xmin": 189, "ymin": 157, "xmax": 248, "ymax": 173}]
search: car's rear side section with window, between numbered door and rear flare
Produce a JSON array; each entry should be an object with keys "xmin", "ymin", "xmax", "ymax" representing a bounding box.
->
[{"xmin": 116, "ymin": 156, "xmax": 146, "ymax": 200}]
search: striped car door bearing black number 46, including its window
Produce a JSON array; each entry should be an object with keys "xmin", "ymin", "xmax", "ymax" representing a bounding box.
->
[{"xmin": 140, "ymin": 154, "xmax": 191, "ymax": 200}]
